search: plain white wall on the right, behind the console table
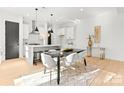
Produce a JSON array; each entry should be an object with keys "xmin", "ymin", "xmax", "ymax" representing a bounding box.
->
[{"xmin": 77, "ymin": 11, "xmax": 124, "ymax": 61}]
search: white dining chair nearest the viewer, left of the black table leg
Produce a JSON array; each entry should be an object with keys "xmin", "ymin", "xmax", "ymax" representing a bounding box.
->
[{"xmin": 41, "ymin": 53, "xmax": 56, "ymax": 84}]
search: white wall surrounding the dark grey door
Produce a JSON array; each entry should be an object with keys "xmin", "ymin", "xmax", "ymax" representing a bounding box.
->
[{"xmin": 0, "ymin": 12, "xmax": 23, "ymax": 60}]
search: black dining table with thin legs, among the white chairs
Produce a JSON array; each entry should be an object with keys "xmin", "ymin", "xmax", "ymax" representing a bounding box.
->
[{"xmin": 45, "ymin": 49, "xmax": 87, "ymax": 85}]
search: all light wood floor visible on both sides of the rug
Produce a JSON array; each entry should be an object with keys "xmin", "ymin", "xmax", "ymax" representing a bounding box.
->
[{"xmin": 0, "ymin": 57, "xmax": 124, "ymax": 86}]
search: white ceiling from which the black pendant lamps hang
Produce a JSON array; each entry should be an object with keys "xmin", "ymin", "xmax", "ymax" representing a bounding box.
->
[{"xmin": 0, "ymin": 7, "xmax": 124, "ymax": 22}]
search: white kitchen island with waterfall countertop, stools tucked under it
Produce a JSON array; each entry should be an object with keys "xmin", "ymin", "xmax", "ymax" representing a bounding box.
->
[{"xmin": 25, "ymin": 45, "xmax": 60, "ymax": 65}]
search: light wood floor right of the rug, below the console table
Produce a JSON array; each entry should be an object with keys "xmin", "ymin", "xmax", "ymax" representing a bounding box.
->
[{"xmin": 87, "ymin": 57, "xmax": 124, "ymax": 86}]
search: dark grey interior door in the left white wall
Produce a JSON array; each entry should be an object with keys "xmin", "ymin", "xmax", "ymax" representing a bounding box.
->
[{"xmin": 5, "ymin": 21, "xmax": 19, "ymax": 59}]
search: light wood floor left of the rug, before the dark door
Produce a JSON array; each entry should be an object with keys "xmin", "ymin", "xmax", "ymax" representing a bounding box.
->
[{"xmin": 0, "ymin": 59, "xmax": 43, "ymax": 86}]
